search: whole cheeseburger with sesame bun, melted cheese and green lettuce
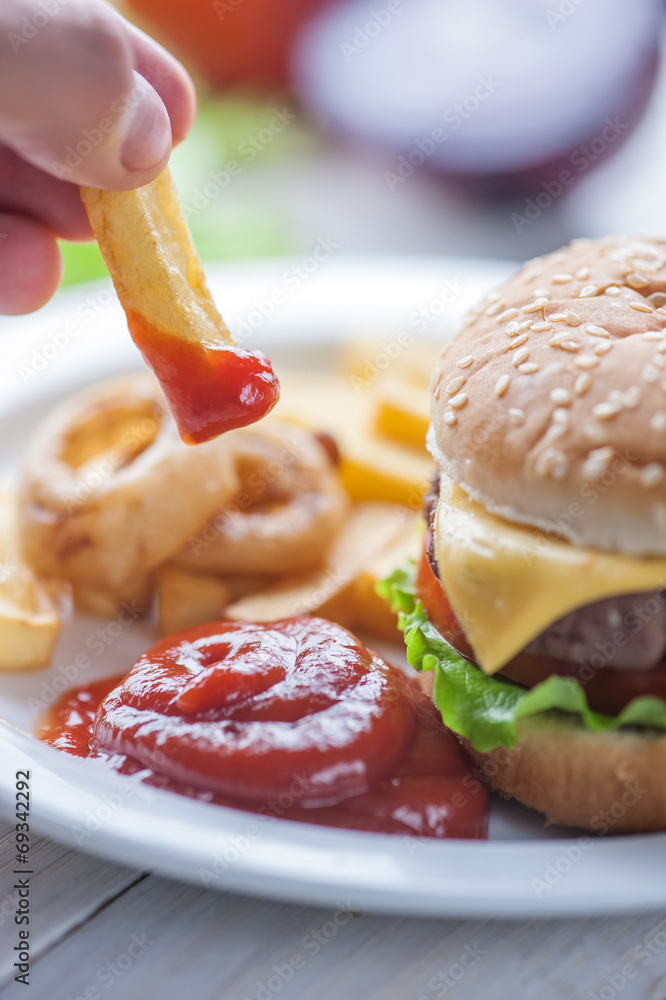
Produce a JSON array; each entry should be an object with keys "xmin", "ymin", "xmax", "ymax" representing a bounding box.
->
[{"xmin": 386, "ymin": 237, "xmax": 666, "ymax": 832}]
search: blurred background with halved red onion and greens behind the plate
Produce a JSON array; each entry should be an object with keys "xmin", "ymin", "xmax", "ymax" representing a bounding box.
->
[{"xmin": 65, "ymin": 0, "xmax": 666, "ymax": 283}]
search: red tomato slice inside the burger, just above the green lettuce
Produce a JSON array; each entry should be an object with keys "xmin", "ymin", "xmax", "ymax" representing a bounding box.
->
[{"xmin": 416, "ymin": 535, "xmax": 666, "ymax": 715}]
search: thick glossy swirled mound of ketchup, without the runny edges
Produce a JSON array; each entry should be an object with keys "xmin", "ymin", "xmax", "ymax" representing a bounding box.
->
[{"xmin": 93, "ymin": 617, "xmax": 416, "ymax": 805}]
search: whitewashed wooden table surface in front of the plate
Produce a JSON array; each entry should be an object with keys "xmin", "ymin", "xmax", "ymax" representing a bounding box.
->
[{"xmin": 0, "ymin": 820, "xmax": 666, "ymax": 1000}]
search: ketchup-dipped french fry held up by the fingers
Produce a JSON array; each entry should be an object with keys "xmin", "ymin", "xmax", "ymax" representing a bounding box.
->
[{"xmin": 81, "ymin": 170, "xmax": 279, "ymax": 444}]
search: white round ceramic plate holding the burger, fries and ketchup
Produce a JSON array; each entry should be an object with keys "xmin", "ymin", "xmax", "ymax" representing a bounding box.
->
[{"xmin": 0, "ymin": 256, "xmax": 666, "ymax": 917}]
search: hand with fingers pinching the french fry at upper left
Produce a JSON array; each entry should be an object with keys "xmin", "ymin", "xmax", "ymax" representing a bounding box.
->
[{"xmin": 0, "ymin": 0, "xmax": 196, "ymax": 314}]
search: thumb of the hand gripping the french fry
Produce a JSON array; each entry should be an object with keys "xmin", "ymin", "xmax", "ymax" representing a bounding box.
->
[{"xmin": 0, "ymin": 0, "xmax": 171, "ymax": 190}]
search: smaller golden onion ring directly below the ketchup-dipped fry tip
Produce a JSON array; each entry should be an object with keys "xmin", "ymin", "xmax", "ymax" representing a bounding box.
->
[{"xmin": 175, "ymin": 420, "xmax": 349, "ymax": 575}]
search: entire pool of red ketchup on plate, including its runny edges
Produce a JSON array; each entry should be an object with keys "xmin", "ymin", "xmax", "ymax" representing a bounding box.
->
[{"xmin": 38, "ymin": 617, "xmax": 488, "ymax": 839}]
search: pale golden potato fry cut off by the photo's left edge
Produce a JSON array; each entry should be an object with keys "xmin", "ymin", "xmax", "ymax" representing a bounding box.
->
[{"xmin": 0, "ymin": 490, "xmax": 64, "ymax": 670}]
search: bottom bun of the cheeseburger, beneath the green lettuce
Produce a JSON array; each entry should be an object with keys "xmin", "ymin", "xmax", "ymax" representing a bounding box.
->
[{"xmin": 421, "ymin": 671, "xmax": 666, "ymax": 834}]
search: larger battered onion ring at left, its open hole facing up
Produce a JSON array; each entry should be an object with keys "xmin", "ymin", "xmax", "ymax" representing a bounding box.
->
[{"xmin": 20, "ymin": 374, "xmax": 237, "ymax": 592}]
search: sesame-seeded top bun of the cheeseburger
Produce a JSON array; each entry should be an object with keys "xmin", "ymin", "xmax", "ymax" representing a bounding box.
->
[{"xmin": 429, "ymin": 236, "xmax": 666, "ymax": 560}]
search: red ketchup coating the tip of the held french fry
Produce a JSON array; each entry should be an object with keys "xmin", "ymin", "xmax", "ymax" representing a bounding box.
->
[{"xmin": 127, "ymin": 312, "xmax": 280, "ymax": 444}]
